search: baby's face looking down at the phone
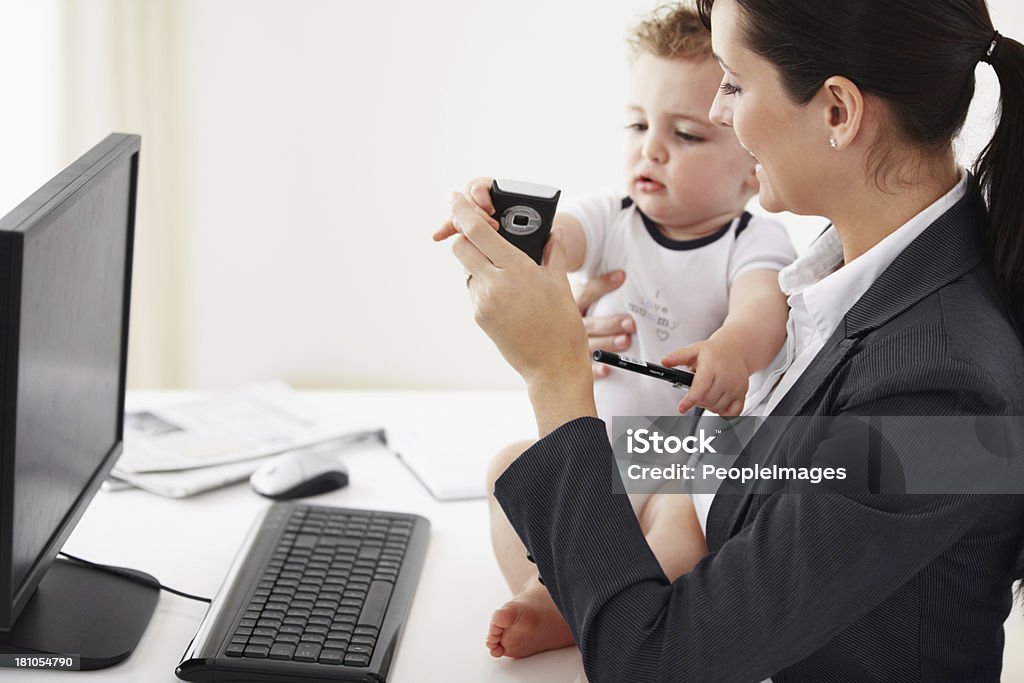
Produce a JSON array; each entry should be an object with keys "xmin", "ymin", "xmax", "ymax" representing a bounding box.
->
[{"xmin": 626, "ymin": 54, "xmax": 757, "ymax": 228}]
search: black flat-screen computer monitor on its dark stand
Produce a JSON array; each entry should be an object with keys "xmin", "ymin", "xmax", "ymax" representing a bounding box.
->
[{"xmin": 0, "ymin": 134, "xmax": 157, "ymax": 668}]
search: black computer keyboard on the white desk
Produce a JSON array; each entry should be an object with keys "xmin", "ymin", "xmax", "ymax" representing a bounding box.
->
[{"xmin": 175, "ymin": 503, "xmax": 430, "ymax": 682}]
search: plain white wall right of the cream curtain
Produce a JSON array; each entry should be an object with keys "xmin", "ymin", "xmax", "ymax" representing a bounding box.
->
[{"xmin": 174, "ymin": 0, "xmax": 649, "ymax": 387}]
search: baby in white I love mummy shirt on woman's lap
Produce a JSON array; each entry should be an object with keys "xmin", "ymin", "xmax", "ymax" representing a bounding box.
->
[{"xmin": 434, "ymin": 5, "xmax": 796, "ymax": 657}]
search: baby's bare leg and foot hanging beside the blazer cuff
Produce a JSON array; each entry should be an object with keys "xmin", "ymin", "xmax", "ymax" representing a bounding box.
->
[{"xmin": 486, "ymin": 441, "xmax": 573, "ymax": 657}]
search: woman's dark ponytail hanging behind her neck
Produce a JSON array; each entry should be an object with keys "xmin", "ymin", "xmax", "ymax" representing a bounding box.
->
[{"xmin": 975, "ymin": 34, "xmax": 1024, "ymax": 333}]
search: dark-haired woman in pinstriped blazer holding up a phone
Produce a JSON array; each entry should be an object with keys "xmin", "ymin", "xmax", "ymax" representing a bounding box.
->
[{"xmin": 452, "ymin": 0, "xmax": 1024, "ymax": 683}]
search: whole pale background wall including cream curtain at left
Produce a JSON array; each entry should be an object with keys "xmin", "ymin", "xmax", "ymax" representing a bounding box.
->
[{"xmin": 6, "ymin": 0, "xmax": 1024, "ymax": 387}]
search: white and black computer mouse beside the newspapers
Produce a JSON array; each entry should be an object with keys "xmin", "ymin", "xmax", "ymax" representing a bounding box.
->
[{"xmin": 249, "ymin": 450, "xmax": 348, "ymax": 501}]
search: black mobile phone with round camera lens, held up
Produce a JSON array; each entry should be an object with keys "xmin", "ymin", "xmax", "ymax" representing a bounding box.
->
[{"xmin": 490, "ymin": 179, "xmax": 562, "ymax": 265}]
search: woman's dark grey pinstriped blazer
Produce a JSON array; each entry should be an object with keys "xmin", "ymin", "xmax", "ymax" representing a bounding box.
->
[{"xmin": 495, "ymin": 193, "xmax": 1024, "ymax": 683}]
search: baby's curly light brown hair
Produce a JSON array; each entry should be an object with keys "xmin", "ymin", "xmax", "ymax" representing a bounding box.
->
[{"xmin": 629, "ymin": 2, "xmax": 712, "ymax": 61}]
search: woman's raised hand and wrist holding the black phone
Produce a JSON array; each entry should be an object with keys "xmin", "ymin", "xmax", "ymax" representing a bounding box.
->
[{"xmin": 451, "ymin": 193, "xmax": 593, "ymax": 432}]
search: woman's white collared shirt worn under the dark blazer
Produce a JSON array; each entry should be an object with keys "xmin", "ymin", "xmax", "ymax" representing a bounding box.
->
[{"xmin": 693, "ymin": 171, "xmax": 968, "ymax": 536}]
